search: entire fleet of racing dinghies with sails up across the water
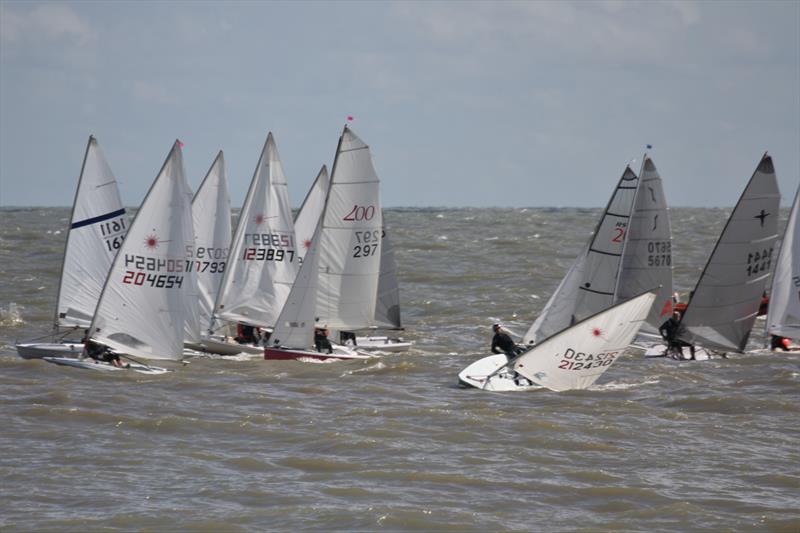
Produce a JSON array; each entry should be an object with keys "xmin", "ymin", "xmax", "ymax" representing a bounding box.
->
[{"xmin": 12, "ymin": 133, "xmax": 800, "ymax": 382}]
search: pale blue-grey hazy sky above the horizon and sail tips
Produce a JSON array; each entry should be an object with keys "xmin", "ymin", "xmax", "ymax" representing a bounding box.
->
[{"xmin": 0, "ymin": 0, "xmax": 800, "ymax": 207}]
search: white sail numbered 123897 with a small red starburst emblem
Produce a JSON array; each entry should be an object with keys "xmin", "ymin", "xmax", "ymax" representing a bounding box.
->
[{"xmin": 215, "ymin": 133, "xmax": 299, "ymax": 327}]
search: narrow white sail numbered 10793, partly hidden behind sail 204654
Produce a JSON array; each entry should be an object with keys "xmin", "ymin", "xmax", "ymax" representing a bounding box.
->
[{"xmin": 187, "ymin": 150, "xmax": 231, "ymax": 334}]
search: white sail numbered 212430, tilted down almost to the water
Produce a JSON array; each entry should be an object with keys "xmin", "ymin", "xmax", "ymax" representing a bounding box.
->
[{"xmin": 512, "ymin": 292, "xmax": 656, "ymax": 391}]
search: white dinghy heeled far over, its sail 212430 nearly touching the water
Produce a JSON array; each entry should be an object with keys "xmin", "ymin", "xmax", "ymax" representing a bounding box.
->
[{"xmin": 458, "ymin": 292, "xmax": 656, "ymax": 392}]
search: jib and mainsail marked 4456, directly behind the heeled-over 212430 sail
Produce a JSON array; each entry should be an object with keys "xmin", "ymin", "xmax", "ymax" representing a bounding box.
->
[{"xmin": 523, "ymin": 167, "xmax": 639, "ymax": 344}]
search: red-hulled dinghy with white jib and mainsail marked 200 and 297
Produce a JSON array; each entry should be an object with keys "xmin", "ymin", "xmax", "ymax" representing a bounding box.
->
[{"xmin": 264, "ymin": 126, "xmax": 383, "ymax": 360}]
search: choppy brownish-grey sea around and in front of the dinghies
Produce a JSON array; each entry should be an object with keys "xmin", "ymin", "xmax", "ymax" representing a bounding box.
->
[{"xmin": 0, "ymin": 208, "xmax": 800, "ymax": 532}]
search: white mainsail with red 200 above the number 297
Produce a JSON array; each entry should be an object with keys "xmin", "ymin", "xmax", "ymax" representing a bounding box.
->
[{"xmin": 317, "ymin": 127, "xmax": 383, "ymax": 330}]
